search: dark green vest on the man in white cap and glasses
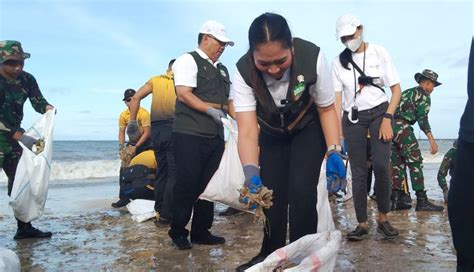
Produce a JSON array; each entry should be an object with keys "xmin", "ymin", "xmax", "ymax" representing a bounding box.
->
[{"xmin": 173, "ymin": 51, "xmax": 230, "ymax": 138}]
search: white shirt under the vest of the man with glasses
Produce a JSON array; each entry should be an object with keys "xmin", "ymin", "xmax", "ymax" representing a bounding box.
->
[{"xmin": 172, "ymin": 48, "xmax": 219, "ymax": 88}]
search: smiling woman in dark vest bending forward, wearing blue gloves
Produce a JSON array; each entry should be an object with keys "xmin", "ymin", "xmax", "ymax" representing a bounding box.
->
[{"xmin": 231, "ymin": 13, "xmax": 345, "ymax": 271}]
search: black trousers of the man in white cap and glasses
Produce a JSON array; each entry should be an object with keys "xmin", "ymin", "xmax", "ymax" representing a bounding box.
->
[{"xmin": 168, "ymin": 133, "xmax": 224, "ymax": 239}]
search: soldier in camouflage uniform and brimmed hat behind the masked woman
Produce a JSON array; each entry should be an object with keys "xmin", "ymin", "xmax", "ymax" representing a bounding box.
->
[{"xmin": 391, "ymin": 69, "xmax": 444, "ymax": 211}]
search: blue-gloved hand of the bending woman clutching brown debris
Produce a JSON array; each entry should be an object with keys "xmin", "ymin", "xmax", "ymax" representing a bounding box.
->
[{"xmin": 239, "ymin": 164, "xmax": 273, "ymax": 219}]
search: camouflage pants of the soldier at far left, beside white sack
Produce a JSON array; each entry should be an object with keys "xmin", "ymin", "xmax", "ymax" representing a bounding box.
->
[{"xmin": 0, "ymin": 133, "xmax": 23, "ymax": 195}]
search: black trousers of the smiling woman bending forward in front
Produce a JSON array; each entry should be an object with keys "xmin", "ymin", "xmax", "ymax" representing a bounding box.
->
[{"xmin": 260, "ymin": 121, "xmax": 327, "ymax": 255}]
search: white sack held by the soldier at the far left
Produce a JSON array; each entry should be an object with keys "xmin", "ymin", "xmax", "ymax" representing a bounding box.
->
[{"xmin": 9, "ymin": 110, "xmax": 55, "ymax": 222}]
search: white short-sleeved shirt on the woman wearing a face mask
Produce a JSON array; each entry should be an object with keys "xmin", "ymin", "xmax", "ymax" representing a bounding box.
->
[{"xmin": 332, "ymin": 43, "xmax": 400, "ymax": 111}]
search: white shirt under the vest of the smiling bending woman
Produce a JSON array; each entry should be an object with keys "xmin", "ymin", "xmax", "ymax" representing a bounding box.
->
[{"xmin": 231, "ymin": 52, "xmax": 335, "ymax": 112}]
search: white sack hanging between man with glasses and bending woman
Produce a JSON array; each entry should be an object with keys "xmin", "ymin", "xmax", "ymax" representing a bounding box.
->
[{"xmin": 199, "ymin": 119, "xmax": 250, "ymax": 212}]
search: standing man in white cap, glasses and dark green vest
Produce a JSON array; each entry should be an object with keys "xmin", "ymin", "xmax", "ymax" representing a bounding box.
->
[{"xmin": 168, "ymin": 21, "xmax": 234, "ymax": 250}]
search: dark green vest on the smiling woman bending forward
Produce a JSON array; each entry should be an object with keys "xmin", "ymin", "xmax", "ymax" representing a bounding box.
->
[{"xmin": 237, "ymin": 38, "xmax": 319, "ymax": 135}]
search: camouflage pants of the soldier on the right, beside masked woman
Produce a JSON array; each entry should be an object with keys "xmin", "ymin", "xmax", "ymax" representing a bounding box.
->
[{"xmin": 391, "ymin": 120, "xmax": 425, "ymax": 191}]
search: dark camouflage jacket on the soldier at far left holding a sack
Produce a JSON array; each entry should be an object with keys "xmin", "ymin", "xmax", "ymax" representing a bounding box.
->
[{"xmin": 0, "ymin": 71, "xmax": 49, "ymax": 135}]
